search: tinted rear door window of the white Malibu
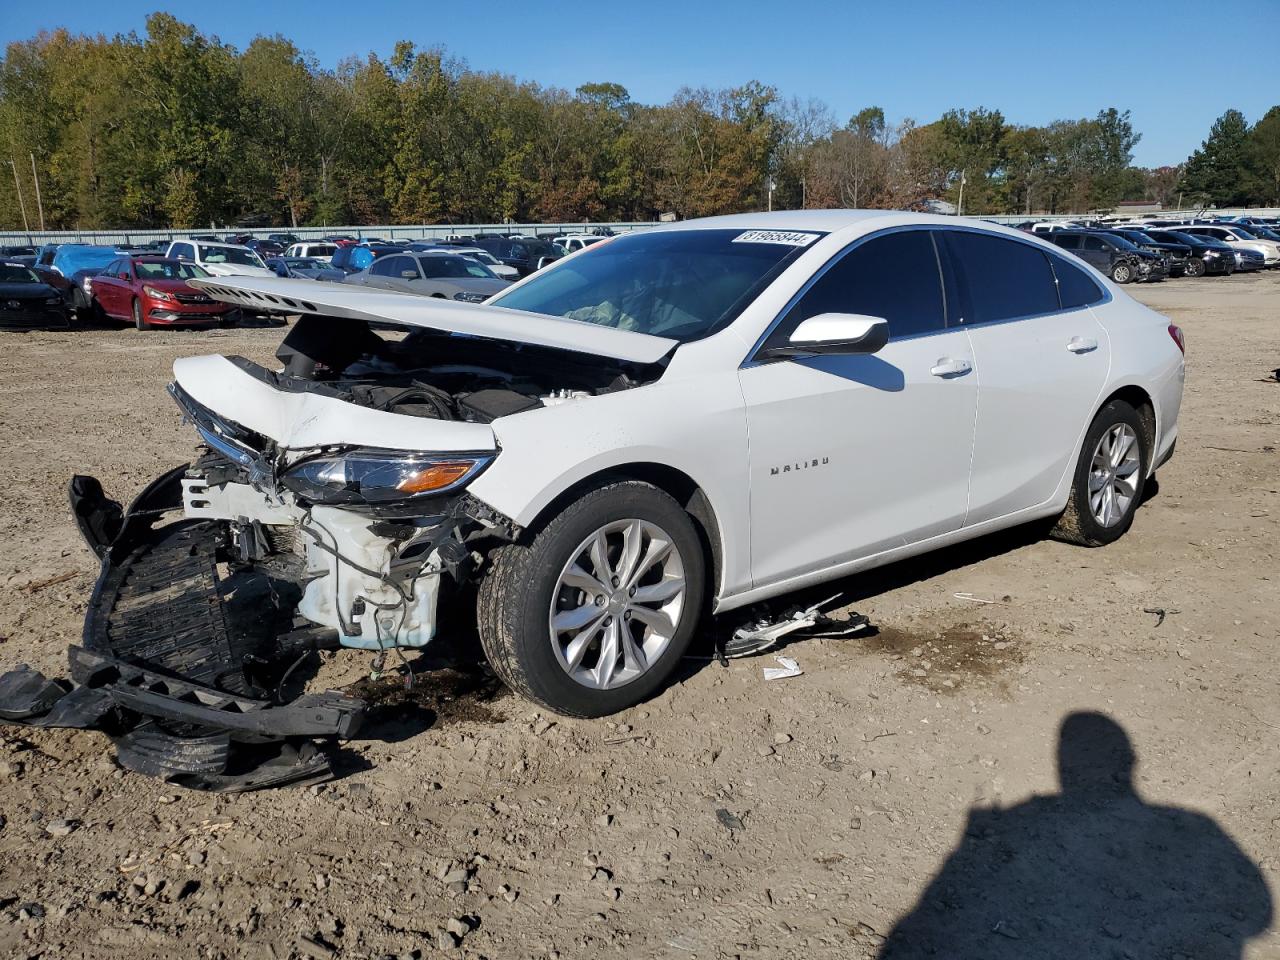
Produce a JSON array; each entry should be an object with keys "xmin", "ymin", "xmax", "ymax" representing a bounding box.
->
[{"xmin": 943, "ymin": 230, "xmax": 1059, "ymax": 324}]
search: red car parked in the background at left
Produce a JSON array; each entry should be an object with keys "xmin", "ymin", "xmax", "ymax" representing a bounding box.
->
[{"xmin": 92, "ymin": 257, "xmax": 239, "ymax": 330}]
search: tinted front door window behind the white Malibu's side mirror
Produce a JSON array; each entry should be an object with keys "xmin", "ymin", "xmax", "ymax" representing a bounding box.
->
[{"xmin": 762, "ymin": 230, "xmax": 946, "ymax": 346}]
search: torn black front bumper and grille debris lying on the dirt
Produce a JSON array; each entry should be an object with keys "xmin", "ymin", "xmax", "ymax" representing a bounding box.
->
[{"xmin": 0, "ymin": 466, "xmax": 365, "ymax": 792}]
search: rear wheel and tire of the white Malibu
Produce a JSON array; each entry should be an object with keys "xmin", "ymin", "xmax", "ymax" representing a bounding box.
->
[{"xmin": 1050, "ymin": 399, "xmax": 1153, "ymax": 547}]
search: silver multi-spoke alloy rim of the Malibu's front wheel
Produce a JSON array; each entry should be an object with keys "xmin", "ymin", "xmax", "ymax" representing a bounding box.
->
[{"xmin": 548, "ymin": 518, "xmax": 686, "ymax": 690}]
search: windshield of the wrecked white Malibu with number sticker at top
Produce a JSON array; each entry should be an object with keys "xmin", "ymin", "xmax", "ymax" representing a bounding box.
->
[{"xmin": 489, "ymin": 230, "xmax": 823, "ymax": 342}]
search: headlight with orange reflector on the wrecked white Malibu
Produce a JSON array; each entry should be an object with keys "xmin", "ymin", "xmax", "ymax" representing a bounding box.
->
[{"xmin": 280, "ymin": 449, "xmax": 493, "ymax": 506}]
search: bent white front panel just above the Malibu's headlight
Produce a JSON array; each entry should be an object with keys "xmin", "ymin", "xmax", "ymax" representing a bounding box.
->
[{"xmin": 173, "ymin": 356, "xmax": 497, "ymax": 453}]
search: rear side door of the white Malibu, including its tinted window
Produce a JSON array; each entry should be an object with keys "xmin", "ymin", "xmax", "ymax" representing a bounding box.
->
[{"xmin": 943, "ymin": 230, "xmax": 1110, "ymax": 526}]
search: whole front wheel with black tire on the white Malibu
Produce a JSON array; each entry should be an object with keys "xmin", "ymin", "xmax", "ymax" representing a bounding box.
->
[{"xmin": 476, "ymin": 481, "xmax": 705, "ymax": 717}]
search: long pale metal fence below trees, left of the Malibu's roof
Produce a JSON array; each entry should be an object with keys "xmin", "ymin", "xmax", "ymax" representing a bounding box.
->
[{"xmin": 0, "ymin": 220, "xmax": 655, "ymax": 247}]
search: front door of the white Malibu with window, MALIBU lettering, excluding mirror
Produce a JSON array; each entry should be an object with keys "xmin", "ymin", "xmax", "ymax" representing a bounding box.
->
[{"xmin": 740, "ymin": 229, "xmax": 978, "ymax": 588}]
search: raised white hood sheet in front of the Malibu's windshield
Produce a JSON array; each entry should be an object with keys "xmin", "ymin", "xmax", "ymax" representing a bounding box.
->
[{"xmin": 191, "ymin": 275, "xmax": 677, "ymax": 364}]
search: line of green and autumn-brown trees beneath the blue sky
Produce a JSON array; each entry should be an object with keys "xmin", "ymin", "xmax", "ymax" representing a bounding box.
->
[{"xmin": 0, "ymin": 13, "xmax": 1280, "ymax": 229}]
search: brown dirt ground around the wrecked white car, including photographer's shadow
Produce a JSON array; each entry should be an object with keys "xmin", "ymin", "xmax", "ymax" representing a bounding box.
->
[{"xmin": 0, "ymin": 271, "xmax": 1280, "ymax": 960}]
